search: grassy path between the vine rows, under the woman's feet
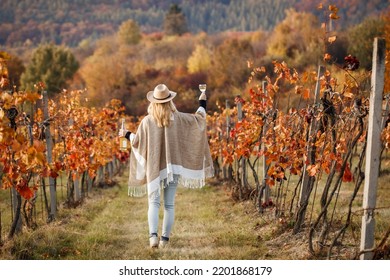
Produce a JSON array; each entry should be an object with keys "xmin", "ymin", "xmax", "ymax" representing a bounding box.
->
[{"xmin": 0, "ymin": 174, "xmax": 269, "ymax": 260}]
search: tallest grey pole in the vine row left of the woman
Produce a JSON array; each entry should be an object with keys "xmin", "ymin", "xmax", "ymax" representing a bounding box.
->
[{"xmin": 43, "ymin": 91, "xmax": 57, "ymax": 221}]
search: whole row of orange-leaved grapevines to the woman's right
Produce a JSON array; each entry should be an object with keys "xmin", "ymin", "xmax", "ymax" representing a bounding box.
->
[{"xmin": 206, "ymin": 38, "xmax": 390, "ymax": 259}]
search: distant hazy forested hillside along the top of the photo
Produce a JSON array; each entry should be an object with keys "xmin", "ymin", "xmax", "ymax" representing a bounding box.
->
[{"xmin": 0, "ymin": 0, "xmax": 390, "ymax": 47}]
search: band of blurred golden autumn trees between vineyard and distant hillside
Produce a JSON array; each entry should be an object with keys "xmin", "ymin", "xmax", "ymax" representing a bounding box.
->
[{"xmin": 4, "ymin": 1, "xmax": 386, "ymax": 116}]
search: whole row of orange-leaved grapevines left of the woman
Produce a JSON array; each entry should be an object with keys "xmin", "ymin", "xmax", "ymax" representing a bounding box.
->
[{"xmin": 0, "ymin": 64, "xmax": 135, "ymax": 240}]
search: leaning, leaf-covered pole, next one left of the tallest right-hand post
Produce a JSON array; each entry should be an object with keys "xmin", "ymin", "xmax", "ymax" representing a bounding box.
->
[{"xmin": 294, "ymin": 65, "xmax": 325, "ymax": 234}]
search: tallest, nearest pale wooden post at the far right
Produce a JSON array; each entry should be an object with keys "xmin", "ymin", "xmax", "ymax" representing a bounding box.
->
[{"xmin": 360, "ymin": 38, "xmax": 386, "ymax": 260}]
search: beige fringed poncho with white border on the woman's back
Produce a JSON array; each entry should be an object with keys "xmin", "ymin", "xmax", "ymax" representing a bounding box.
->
[{"xmin": 129, "ymin": 108, "xmax": 214, "ymax": 196}]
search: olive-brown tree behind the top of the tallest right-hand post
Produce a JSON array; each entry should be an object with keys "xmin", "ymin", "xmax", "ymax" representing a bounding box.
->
[{"xmin": 348, "ymin": 18, "xmax": 385, "ymax": 69}]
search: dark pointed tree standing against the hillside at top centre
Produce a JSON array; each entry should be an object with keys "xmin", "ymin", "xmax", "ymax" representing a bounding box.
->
[{"xmin": 164, "ymin": 4, "xmax": 187, "ymax": 36}]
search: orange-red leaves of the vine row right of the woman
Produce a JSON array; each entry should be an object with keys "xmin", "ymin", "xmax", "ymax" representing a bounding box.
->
[{"xmin": 209, "ymin": 58, "xmax": 368, "ymax": 186}]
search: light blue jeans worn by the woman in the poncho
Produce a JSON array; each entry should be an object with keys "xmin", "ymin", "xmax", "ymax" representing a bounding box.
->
[{"xmin": 148, "ymin": 175, "xmax": 178, "ymax": 240}]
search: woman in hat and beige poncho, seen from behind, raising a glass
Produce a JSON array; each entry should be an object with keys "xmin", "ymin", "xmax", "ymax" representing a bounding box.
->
[{"xmin": 119, "ymin": 84, "xmax": 213, "ymax": 248}]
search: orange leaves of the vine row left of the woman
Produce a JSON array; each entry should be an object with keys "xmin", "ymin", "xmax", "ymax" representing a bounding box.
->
[{"xmin": 0, "ymin": 55, "xmax": 134, "ymax": 200}]
